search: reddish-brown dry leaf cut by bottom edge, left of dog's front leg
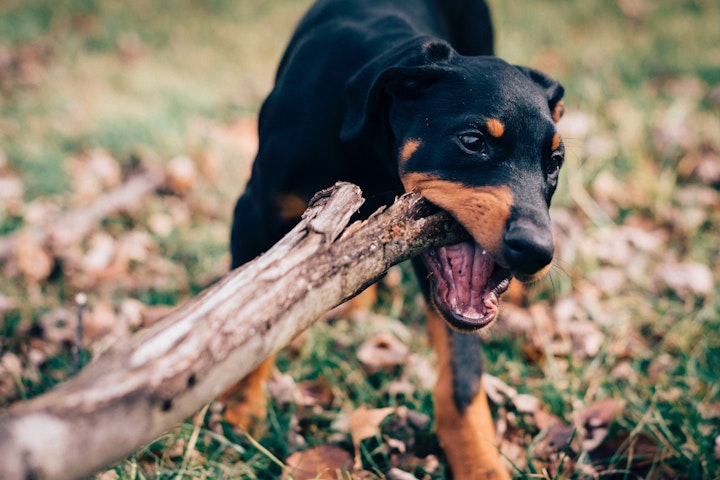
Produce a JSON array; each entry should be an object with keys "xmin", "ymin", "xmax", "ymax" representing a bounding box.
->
[{"xmin": 282, "ymin": 445, "xmax": 352, "ymax": 480}]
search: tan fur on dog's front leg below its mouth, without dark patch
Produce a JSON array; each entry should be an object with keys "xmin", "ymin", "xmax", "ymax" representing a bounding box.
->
[{"xmin": 427, "ymin": 307, "xmax": 510, "ymax": 480}]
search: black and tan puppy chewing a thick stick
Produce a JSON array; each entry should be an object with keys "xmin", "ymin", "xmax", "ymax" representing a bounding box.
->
[{"xmin": 224, "ymin": 0, "xmax": 563, "ymax": 479}]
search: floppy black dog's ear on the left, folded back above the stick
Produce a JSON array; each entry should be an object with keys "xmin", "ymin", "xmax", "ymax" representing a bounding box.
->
[{"xmin": 340, "ymin": 38, "xmax": 455, "ymax": 140}]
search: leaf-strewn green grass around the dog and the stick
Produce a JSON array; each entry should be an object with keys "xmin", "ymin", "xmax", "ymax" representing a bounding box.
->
[{"xmin": 0, "ymin": 0, "xmax": 720, "ymax": 479}]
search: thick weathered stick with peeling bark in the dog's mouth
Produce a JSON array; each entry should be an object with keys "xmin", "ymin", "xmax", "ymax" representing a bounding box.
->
[{"xmin": 0, "ymin": 183, "xmax": 466, "ymax": 480}]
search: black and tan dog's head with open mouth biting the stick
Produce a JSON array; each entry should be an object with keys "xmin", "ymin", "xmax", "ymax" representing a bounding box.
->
[{"xmin": 341, "ymin": 39, "xmax": 564, "ymax": 330}]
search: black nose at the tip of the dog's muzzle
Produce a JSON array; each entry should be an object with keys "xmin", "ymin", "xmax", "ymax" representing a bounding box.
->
[{"xmin": 503, "ymin": 220, "xmax": 555, "ymax": 280}]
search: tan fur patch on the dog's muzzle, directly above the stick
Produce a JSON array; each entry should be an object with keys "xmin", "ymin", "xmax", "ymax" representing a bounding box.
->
[{"xmin": 402, "ymin": 172, "xmax": 513, "ymax": 256}]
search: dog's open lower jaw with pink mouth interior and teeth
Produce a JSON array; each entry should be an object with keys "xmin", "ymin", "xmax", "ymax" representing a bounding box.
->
[{"xmin": 423, "ymin": 241, "xmax": 510, "ymax": 330}]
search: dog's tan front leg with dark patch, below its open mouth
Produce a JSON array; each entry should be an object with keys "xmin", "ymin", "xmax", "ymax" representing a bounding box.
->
[{"xmin": 428, "ymin": 307, "xmax": 510, "ymax": 480}]
